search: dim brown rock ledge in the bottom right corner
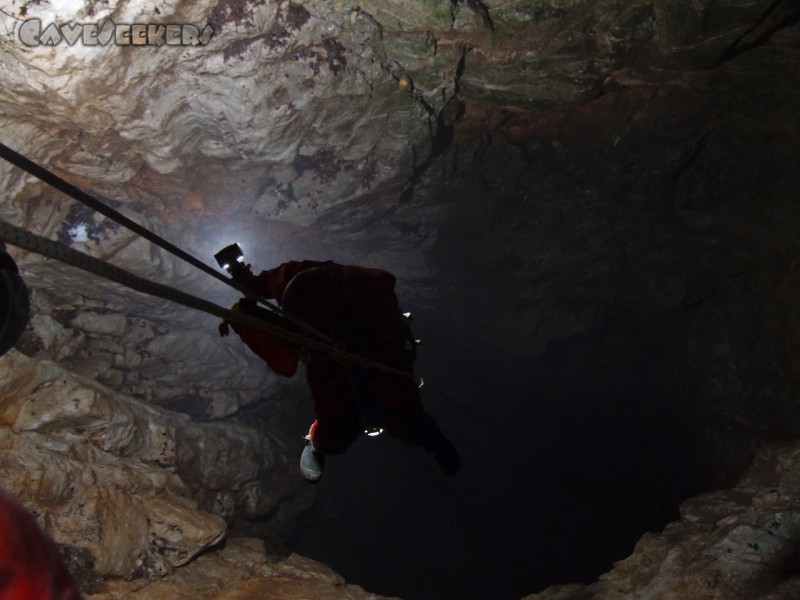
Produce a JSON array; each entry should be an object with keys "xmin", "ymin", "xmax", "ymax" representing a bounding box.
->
[{"xmin": 526, "ymin": 444, "xmax": 800, "ymax": 600}]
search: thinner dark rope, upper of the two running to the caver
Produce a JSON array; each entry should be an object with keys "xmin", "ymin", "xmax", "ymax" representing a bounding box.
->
[{"xmin": 0, "ymin": 144, "xmax": 331, "ymax": 342}]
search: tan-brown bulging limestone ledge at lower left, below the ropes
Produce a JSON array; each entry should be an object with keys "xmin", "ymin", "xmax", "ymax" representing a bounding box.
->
[{"xmin": 0, "ymin": 351, "xmax": 285, "ymax": 577}]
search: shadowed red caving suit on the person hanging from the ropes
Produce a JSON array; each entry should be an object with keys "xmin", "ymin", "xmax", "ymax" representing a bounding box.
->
[{"xmin": 238, "ymin": 260, "xmax": 442, "ymax": 454}]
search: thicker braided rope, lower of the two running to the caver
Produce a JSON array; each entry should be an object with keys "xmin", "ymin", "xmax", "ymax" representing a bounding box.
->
[{"xmin": 0, "ymin": 220, "xmax": 414, "ymax": 378}]
